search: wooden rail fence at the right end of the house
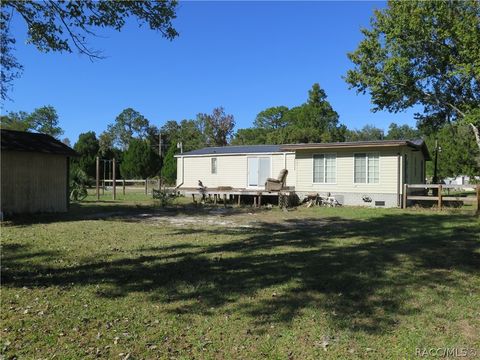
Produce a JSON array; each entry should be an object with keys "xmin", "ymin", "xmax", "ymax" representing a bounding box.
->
[{"xmin": 402, "ymin": 184, "xmax": 480, "ymax": 213}]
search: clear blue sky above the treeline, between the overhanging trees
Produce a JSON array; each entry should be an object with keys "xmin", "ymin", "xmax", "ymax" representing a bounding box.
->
[{"xmin": 3, "ymin": 2, "xmax": 415, "ymax": 144}]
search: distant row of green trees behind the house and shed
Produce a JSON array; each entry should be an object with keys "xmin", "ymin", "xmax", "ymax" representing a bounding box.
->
[{"xmin": 1, "ymin": 84, "xmax": 480, "ymax": 184}]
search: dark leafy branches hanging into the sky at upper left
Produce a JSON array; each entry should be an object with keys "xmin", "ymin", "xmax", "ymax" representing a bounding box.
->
[{"xmin": 0, "ymin": 0, "xmax": 178, "ymax": 99}]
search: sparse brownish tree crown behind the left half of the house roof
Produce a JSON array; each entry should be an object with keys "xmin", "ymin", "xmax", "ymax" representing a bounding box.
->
[{"xmin": 197, "ymin": 107, "xmax": 235, "ymax": 146}]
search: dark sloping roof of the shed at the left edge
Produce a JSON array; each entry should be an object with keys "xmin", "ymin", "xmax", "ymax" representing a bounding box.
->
[{"xmin": 0, "ymin": 129, "xmax": 78, "ymax": 156}]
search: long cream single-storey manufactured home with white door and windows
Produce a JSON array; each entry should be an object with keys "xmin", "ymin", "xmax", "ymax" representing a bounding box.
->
[{"xmin": 176, "ymin": 140, "xmax": 430, "ymax": 207}]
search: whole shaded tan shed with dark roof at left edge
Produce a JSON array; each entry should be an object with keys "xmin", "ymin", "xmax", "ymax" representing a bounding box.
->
[{"xmin": 1, "ymin": 129, "xmax": 77, "ymax": 214}]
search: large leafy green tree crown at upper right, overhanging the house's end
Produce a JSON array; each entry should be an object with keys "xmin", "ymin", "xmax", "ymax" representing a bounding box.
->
[{"xmin": 346, "ymin": 0, "xmax": 480, "ymax": 142}]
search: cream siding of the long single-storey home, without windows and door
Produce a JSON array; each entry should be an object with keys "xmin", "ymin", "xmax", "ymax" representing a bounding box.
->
[{"xmin": 177, "ymin": 146, "xmax": 425, "ymax": 207}]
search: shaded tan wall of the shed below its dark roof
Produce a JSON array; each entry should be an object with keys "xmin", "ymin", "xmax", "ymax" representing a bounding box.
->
[{"xmin": 1, "ymin": 151, "xmax": 68, "ymax": 214}]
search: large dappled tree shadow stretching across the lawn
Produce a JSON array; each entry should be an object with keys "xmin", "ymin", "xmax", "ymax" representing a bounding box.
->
[{"xmin": 2, "ymin": 213, "xmax": 480, "ymax": 333}]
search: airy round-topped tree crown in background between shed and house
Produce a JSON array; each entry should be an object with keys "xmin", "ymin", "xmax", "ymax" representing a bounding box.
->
[{"xmin": 107, "ymin": 108, "xmax": 150, "ymax": 150}]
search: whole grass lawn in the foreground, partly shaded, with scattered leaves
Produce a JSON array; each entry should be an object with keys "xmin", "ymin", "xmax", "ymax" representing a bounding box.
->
[{"xmin": 1, "ymin": 198, "xmax": 480, "ymax": 359}]
